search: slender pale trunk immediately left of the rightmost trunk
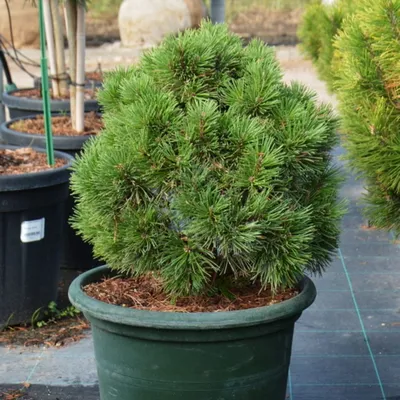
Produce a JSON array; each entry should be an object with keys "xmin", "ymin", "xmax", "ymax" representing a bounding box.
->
[{"xmin": 64, "ymin": 0, "xmax": 77, "ymax": 129}]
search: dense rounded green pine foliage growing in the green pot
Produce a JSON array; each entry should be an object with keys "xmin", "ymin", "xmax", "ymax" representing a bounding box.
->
[{"xmin": 72, "ymin": 23, "xmax": 343, "ymax": 296}]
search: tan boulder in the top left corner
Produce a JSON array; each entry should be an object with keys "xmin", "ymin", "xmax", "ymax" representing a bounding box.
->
[{"xmin": 0, "ymin": 0, "xmax": 40, "ymax": 48}]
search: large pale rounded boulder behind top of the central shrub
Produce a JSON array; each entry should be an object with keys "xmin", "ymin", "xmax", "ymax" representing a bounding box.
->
[{"xmin": 118, "ymin": 0, "xmax": 207, "ymax": 48}]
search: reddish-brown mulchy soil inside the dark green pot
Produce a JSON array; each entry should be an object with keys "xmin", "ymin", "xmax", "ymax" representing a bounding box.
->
[{"xmin": 84, "ymin": 274, "xmax": 299, "ymax": 313}]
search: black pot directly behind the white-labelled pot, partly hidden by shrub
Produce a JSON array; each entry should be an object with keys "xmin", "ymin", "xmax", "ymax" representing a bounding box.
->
[{"xmin": 0, "ymin": 115, "xmax": 101, "ymax": 271}]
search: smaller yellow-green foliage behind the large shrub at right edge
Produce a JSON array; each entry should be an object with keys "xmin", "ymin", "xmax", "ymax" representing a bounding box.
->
[{"xmin": 298, "ymin": 0, "xmax": 359, "ymax": 91}]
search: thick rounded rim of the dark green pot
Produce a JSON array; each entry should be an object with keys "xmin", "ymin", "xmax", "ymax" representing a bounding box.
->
[{"xmin": 68, "ymin": 265, "xmax": 316, "ymax": 330}]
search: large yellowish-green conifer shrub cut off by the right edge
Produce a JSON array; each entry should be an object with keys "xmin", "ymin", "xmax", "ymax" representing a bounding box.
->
[{"xmin": 335, "ymin": 0, "xmax": 400, "ymax": 234}]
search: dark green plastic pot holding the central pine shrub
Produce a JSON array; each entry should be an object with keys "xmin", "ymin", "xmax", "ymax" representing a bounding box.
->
[{"xmin": 69, "ymin": 266, "xmax": 316, "ymax": 400}]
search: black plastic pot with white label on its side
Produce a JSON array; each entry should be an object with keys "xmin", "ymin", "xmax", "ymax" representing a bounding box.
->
[{"xmin": 0, "ymin": 145, "xmax": 73, "ymax": 326}]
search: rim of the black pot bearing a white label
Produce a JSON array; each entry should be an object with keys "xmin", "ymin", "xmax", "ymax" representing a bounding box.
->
[{"xmin": 0, "ymin": 145, "xmax": 74, "ymax": 192}]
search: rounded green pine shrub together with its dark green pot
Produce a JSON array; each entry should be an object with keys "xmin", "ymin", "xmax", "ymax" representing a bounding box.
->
[{"xmin": 69, "ymin": 22, "xmax": 343, "ymax": 400}]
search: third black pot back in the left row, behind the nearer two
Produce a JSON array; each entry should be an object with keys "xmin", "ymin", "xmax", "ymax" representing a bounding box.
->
[{"xmin": 3, "ymin": 88, "xmax": 100, "ymax": 118}]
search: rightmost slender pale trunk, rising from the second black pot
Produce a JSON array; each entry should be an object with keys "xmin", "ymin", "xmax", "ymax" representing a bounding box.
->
[{"xmin": 76, "ymin": 3, "xmax": 86, "ymax": 133}]
